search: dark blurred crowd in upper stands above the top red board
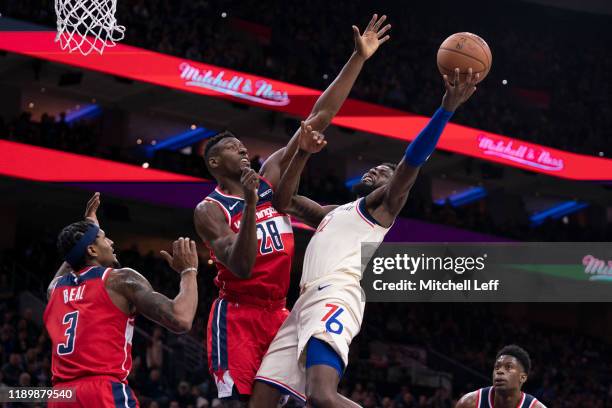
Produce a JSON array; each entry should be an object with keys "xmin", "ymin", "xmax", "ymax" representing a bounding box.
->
[{"xmin": 0, "ymin": 0, "xmax": 612, "ymax": 157}]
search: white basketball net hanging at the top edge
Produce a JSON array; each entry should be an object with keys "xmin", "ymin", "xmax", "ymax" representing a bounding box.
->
[{"xmin": 55, "ymin": 0, "xmax": 125, "ymax": 55}]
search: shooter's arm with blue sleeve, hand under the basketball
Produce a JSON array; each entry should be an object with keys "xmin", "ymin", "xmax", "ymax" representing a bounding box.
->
[{"xmin": 366, "ymin": 68, "xmax": 479, "ymax": 227}]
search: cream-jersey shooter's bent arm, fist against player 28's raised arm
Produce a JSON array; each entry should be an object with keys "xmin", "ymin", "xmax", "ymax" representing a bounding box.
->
[{"xmin": 272, "ymin": 122, "xmax": 336, "ymax": 227}]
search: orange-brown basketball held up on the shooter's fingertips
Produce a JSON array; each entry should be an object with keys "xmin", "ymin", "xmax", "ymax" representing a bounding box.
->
[{"xmin": 438, "ymin": 33, "xmax": 493, "ymax": 82}]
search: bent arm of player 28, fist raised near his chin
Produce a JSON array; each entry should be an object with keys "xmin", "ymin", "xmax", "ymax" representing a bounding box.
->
[{"xmin": 194, "ymin": 168, "xmax": 259, "ymax": 279}]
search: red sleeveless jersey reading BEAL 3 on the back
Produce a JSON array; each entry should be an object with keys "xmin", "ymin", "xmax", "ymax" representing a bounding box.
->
[{"xmin": 43, "ymin": 266, "xmax": 134, "ymax": 384}]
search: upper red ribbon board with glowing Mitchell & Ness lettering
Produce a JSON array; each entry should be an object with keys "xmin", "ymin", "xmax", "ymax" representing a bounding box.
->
[{"xmin": 0, "ymin": 31, "xmax": 612, "ymax": 181}]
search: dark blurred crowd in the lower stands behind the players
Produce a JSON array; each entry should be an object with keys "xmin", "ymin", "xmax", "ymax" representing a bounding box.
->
[{"xmin": 0, "ymin": 236, "xmax": 612, "ymax": 408}]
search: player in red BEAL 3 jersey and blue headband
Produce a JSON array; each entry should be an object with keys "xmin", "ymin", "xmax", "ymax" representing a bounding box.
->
[{"xmin": 43, "ymin": 193, "xmax": 198, "ymax": 408}]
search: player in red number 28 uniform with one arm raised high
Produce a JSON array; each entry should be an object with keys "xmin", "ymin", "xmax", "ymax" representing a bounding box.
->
[{"xmin": 194, "ymin": 15, "xmax": 391, "ymax": 399}]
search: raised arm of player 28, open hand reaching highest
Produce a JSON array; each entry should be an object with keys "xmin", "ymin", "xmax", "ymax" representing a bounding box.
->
[{"xmin": 261, "ymin": 14, "xmax": 391, "ymax": 186}]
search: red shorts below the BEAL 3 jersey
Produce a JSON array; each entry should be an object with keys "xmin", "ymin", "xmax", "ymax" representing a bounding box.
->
[{"xmin": 47, "ymin": 376, "xmax": 140, "ymax": 408}]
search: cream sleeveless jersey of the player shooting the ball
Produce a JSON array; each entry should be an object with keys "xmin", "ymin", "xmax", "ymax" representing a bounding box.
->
[{"xmin": 300, "ymin": 198, "xmax": 389, "ymax": 287}]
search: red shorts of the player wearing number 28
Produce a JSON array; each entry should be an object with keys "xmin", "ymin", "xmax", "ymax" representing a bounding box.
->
[{"xmin": 206, "ymin": 298, "xmax": 289, "ymax": 398}]
